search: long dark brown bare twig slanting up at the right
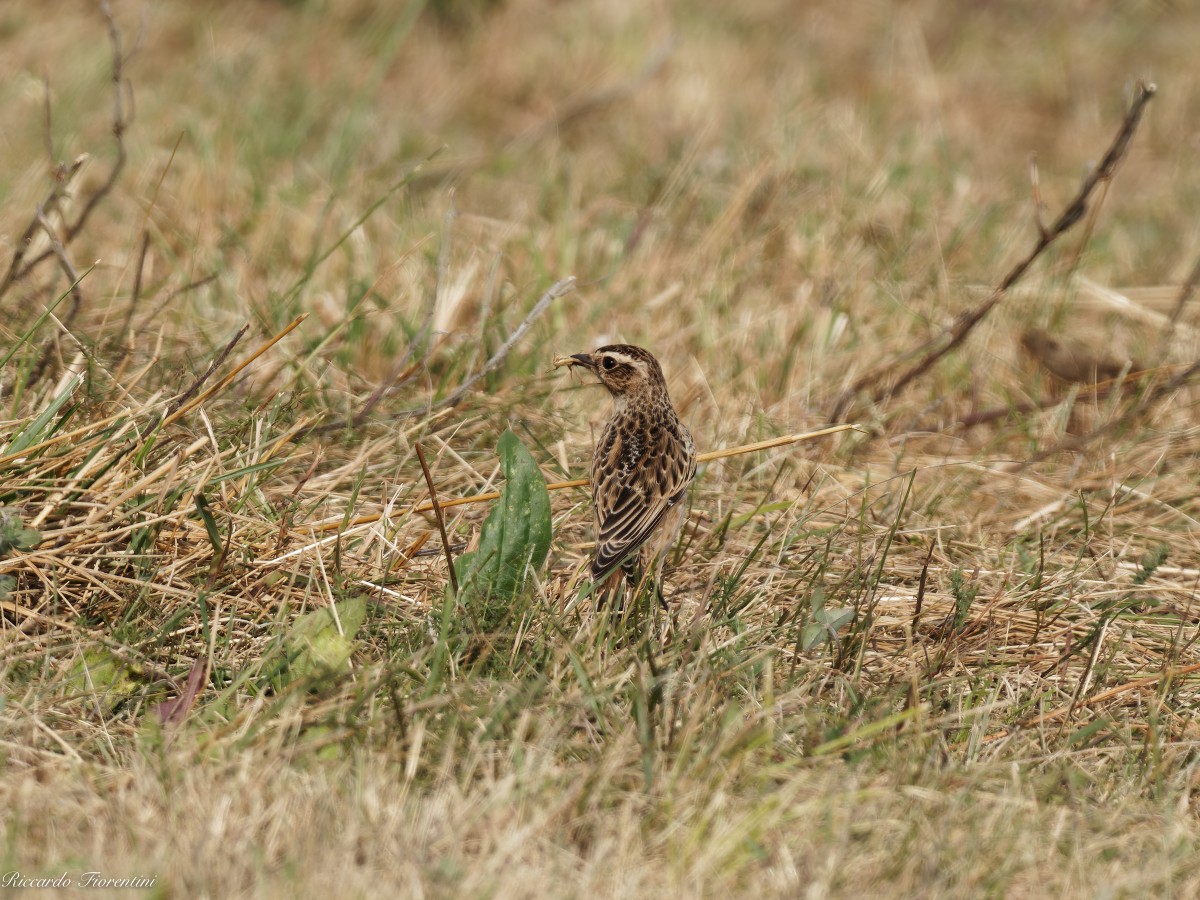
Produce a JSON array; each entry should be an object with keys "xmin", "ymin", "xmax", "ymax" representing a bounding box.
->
[{"xmin": 829, "ymin": 82, "xmax": 1157, "ymax": 419}]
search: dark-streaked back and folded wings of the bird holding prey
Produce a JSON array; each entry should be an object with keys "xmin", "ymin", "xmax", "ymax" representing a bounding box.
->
[{"xmin": 592, "ymin": 426, "xmax": 696, "ymax": 582}]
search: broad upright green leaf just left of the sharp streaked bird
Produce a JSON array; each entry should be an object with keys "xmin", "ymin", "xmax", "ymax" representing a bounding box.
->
[{"xmin": 455, "ymin": 431, "xmax": 551, "ymax": 601}]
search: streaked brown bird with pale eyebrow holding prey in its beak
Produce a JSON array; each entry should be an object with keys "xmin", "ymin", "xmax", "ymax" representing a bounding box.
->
[{"xmin": 554, "ymin": 343, "xmax": 696, "ymax": 605}]
